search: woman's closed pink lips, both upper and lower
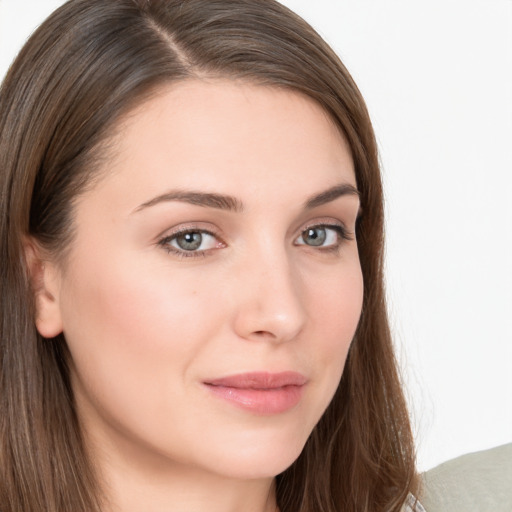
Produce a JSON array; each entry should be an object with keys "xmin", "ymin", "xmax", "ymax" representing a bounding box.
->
[{"xmin": 204, "ymin": 372, "xmax": 307, "ymax": 414}]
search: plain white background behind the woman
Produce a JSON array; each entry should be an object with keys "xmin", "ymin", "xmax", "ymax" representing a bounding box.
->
[{"xmin": 0, "ymin": 0, "xmax": 512, "ymax": 469}]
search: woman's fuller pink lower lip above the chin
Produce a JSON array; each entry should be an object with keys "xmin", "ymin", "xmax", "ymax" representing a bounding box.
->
[{"xmin": 206, "ymin": 384, "xmax": 304, "ymax": 415}]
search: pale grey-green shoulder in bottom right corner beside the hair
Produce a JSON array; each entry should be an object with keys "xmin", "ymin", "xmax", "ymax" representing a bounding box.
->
[{"xmin": 421, "ymin": 443, "xmax": 512, "ymax": 512}]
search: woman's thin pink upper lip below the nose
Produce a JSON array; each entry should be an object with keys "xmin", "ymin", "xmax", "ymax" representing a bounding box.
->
[{"xmin": 205, "ymin": 371, "xmax": 307, "ymax": 389}]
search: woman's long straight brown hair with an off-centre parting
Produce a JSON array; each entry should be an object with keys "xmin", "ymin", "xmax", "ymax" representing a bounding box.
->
[{"xmin": 0, "ymin": 0, "xmax": 415, "ymax": 512}]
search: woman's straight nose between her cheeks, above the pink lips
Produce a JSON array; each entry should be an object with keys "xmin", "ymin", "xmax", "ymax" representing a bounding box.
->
[{"xmin": 234, "ymin": 251, "xmax": 307, "ymax": 343}]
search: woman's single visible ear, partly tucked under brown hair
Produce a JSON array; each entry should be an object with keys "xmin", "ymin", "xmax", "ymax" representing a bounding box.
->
[{"xmin": 24, "ymin": 239, "xmax": 62, "ymax": 338}]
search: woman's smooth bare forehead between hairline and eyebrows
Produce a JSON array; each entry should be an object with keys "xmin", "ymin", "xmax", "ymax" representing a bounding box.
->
[{"xmin": 79, "ymin": 80, "xmax": 355, "ymax": 214}]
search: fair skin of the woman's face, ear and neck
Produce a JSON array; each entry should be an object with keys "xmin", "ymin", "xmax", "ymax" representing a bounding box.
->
[{"xmin": 32, "ymin": 80, "xmax": 363, "ymax": 512}]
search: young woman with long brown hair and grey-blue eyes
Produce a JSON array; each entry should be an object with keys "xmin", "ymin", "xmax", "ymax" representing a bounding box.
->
[{"xmin": 0, "ymin": 0, "xmax": 417, "ymax": 512}]
